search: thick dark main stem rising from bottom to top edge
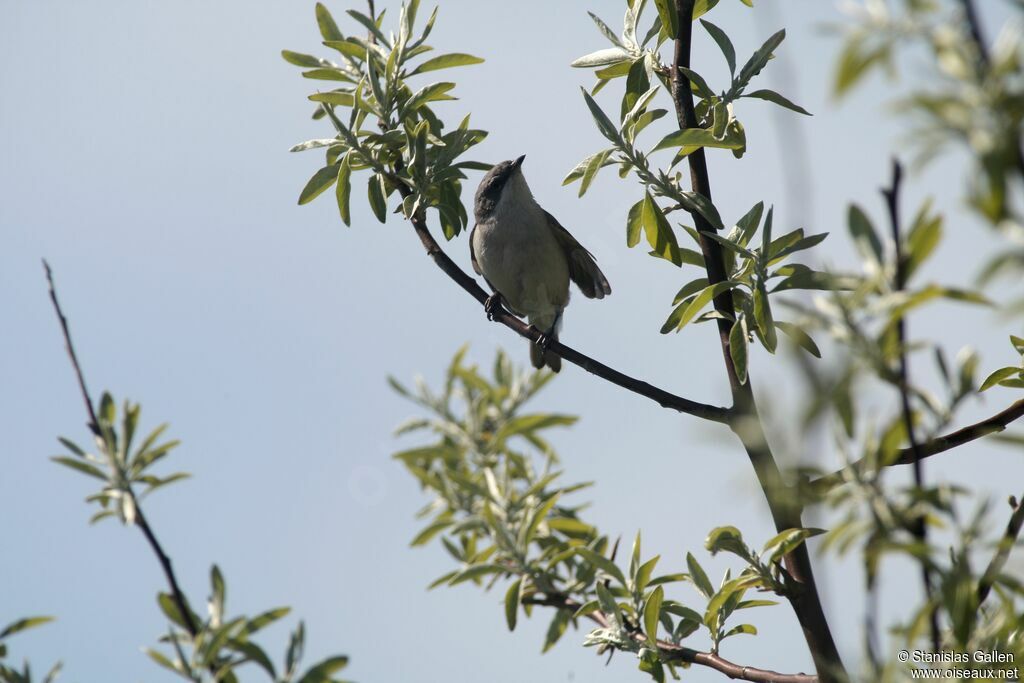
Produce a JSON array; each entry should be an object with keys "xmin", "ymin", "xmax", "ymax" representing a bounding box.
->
[{"xmin": 672, "ymin": 6, "xmax": 849, "ymax": 683}]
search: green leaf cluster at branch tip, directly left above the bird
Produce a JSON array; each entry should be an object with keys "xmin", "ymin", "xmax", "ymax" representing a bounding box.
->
[{"xmin": 282, "ymin": 0, "xmax": 490, "ymax": 240}]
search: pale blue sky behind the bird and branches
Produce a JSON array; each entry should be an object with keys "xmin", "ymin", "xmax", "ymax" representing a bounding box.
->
[{"xmin": 0, "ymin": 0, "xmax": 1024, "ymax": 683}]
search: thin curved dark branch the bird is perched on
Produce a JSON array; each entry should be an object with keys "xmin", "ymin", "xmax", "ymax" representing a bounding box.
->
[{"xmin": 398, "ymin": 196, "xmax": 732, "ymax": 424}]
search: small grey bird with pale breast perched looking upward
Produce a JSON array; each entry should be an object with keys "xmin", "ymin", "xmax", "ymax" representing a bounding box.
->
[{"xmin": 469, "ymin": 156, "xmax": 611, "ymax": 373}]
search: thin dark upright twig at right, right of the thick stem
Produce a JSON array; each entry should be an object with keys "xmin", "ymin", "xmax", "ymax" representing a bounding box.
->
[{"xmin": 882, "ymin": 159, "xmax": 941, "ymax": 652}]
